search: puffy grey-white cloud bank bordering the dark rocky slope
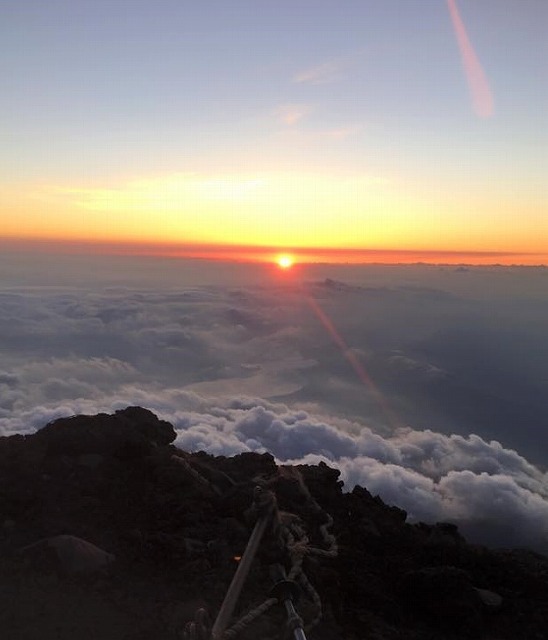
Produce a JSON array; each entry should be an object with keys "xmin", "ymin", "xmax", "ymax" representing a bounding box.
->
[{"xmin": 0, "ymin": 386, "xmax": 548, "ymax": 553}]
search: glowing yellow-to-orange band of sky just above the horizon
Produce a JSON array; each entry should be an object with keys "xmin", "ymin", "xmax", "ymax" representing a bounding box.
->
[{"xmin": 0, "ymin": 171, "xmax": 548, "ymax": 264}]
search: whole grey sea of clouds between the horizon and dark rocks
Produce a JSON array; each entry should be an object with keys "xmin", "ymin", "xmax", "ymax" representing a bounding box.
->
[{"xmin": 0, "ymin": 252, "xmax": 548, "ymax": 552}]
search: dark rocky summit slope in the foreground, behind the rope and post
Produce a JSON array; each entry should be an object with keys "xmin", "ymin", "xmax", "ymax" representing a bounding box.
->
[{"xmin": 0, "ymin": 407, "xmax": 548, "ymax": 640}]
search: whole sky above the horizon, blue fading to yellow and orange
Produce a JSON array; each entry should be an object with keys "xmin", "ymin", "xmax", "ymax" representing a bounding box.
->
[{"xmin": 0, "ymin": 0, "xmax": 548, "ymax": 264}]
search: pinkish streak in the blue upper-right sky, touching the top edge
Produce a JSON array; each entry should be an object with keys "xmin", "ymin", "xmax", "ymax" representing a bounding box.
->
[{"xmin": 447, "ymin": 0, "xmax": 493, "ymax": 118}]
